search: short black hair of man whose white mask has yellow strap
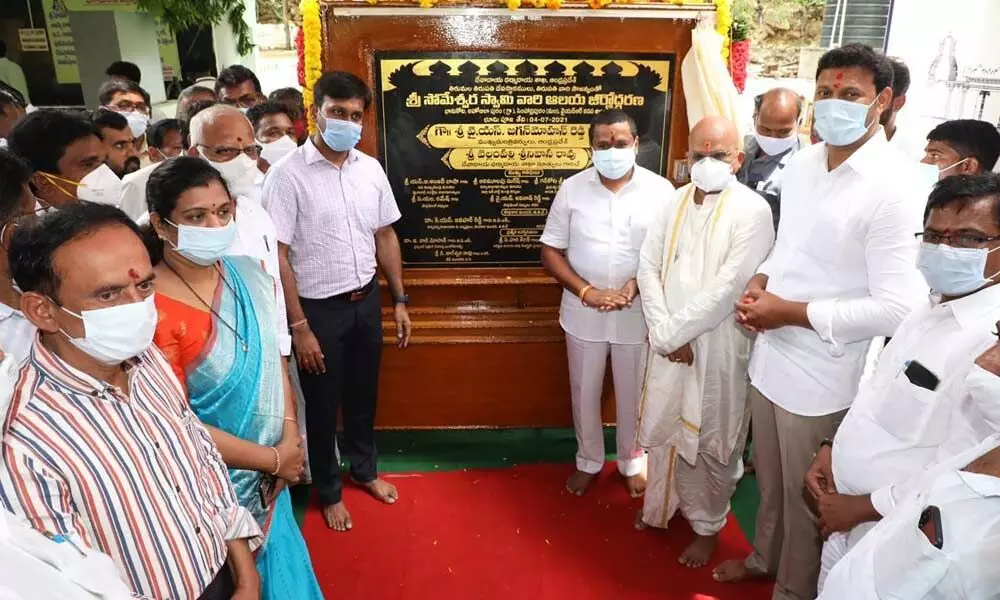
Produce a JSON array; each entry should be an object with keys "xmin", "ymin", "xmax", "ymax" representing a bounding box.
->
[{"xmin": 7, "ymin": 108, "xmax": 101, "ymax": 173}]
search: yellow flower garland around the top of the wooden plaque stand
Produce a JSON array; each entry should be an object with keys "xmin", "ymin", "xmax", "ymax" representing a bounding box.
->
[{"xmin": 299, "ymin": 0, "xmax": 733, "ymax": 133}]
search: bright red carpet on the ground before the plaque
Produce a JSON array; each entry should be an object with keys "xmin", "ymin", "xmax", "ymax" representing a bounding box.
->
[{"xmin": 303, "ymin": 465, "xmax": 771, "ymax": 600}]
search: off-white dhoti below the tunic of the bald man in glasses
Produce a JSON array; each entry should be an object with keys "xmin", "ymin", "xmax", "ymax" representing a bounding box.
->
[{"xmin": 642, "ymin": 446, "xmax": 743, "ymax": 536}]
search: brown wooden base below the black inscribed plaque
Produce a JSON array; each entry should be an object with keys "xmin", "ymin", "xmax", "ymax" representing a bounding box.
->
[{"xmin": 377, "ymin": 269, "xmax": 614, "ymax": 429}]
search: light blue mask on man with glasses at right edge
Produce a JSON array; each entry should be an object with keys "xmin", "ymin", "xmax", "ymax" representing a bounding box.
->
[{"xmin": 917, "ymin": 242, "xmax": 1000, "ymax": 296}]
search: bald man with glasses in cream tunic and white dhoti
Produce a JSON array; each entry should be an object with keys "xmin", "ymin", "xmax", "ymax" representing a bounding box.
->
[{"xmin": 636, "ymin": 117, "xmax": 774, "ymax": 567}]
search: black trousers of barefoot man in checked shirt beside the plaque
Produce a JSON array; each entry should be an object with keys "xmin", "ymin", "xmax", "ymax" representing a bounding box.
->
[{"xmin": 299, "ymin": 283, "xmax": 382, "ymax": 505}]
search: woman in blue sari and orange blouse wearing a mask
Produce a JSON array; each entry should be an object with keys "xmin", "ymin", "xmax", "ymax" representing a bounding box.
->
[{"xmin": 147, "ymin": 157, "xmax": 322, "ymax": 599}]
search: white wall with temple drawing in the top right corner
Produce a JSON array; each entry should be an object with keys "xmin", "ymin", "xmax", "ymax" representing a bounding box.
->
[{"xmin": 888, "ymin": 0, "xmax": 1000, "ymax": 148}]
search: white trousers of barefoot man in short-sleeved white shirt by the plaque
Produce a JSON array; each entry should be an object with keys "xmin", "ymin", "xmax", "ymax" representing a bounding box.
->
[{"xmin": 566, "ymin": 333, "xmax": 645, "ymax": 477}]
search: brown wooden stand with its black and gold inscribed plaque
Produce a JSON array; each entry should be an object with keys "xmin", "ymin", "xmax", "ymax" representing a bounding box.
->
[{"xmin": 321, "ymin": 2, "xmax": 714, "ymax": 428}]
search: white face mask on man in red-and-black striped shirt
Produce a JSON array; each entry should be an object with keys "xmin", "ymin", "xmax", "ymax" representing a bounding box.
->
[{"xmin": 53, "ymin": 294, "xmax": 157, "ymax": 365}]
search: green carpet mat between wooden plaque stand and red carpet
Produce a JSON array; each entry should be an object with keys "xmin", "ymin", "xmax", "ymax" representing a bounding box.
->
[{"xmin": 292, "ymin": 427, "xmax": 760, "ymax": 540}]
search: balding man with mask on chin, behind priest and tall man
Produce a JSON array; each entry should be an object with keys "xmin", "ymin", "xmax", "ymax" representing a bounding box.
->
[{"xmin": 736, "ymin": 88, "xmax": 802, "ymax": 229}]
